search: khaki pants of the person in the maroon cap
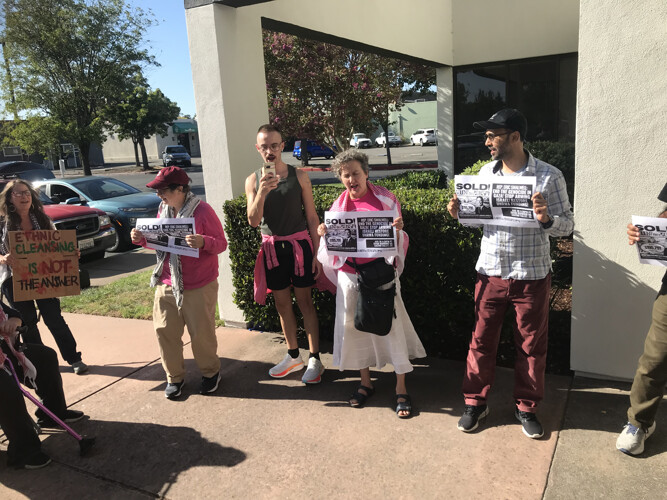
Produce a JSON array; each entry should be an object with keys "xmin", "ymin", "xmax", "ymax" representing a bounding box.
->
[{"xmin": 153, "ymin": 280, "xmax": 220, "ymax": 383}]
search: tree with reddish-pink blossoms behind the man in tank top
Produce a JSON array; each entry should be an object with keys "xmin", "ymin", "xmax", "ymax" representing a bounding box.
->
[{"xmin": 263, "ymin": 30, "xmax": 435, "ymax": 165}]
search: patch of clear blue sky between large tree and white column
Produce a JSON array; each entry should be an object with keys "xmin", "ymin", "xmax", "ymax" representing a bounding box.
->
[{"xmin": 128, "ymin": 0, "xmax": 197, "ymax": 117}]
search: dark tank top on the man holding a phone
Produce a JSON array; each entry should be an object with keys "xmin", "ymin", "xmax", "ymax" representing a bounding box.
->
[{"xmin": 255, "ymin": 165, "xmax": 307, "ymax": 236}]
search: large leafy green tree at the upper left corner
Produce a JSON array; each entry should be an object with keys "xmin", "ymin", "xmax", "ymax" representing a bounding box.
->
[{"xmin": 0, "ymin": 0, "xmax": 155, "ymax": 175}]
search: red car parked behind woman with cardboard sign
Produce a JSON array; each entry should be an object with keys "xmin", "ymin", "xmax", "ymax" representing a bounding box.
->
[{"xmin": 0, "ymin": 179, "xmax": 116, "ymax": 258}]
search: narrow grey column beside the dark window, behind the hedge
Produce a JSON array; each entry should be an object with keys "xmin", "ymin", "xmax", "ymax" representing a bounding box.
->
[{"xmin": 435, "ymin": 66, "xmax": 454, "ymax": 179}]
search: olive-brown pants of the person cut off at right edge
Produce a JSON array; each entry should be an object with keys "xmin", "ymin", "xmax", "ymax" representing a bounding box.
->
[{"xmin": 628, "ymin": 295, "xmax": 667, "ymax": 428}]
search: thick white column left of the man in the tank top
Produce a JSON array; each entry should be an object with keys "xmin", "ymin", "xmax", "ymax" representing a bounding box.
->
[{"xmin": 185, "ymin": 4, "xmax": 269, "ymax": 326}]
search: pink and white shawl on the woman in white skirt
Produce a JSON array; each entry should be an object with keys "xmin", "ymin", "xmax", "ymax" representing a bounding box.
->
[{"xmin": 317, "ymin": 181, "xmax": 410, "ymax": 284}]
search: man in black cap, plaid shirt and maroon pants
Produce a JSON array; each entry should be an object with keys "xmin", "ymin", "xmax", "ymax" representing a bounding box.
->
[{"xmin": 447, "ymin": 109, "xmax": 574, "ymax": 439}]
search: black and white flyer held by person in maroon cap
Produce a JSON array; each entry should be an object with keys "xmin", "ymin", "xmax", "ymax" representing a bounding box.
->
[{"xmin": 135, "ymin": 217, "xmax": 199, "ymax": 258}]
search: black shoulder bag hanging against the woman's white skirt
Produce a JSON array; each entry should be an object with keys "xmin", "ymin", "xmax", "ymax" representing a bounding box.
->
[{"xmin": 353, "ymin": 259, "xmax": 396, "ymax": 336}]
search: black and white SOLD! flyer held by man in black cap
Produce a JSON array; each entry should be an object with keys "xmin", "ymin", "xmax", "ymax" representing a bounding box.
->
[{"xmin": 454, "ymin": 175, "xmax": 539, "ymax": 227}]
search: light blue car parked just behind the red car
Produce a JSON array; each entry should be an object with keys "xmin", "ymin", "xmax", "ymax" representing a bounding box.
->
[{"xmin": 33, "ymin": 176, "xmax": 160, "ymax": 252}]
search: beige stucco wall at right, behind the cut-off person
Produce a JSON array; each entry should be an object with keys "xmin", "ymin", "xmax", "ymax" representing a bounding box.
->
[{"xmin": 571, "ymin": 0, "xmax": 667, "ymax": 378}]
